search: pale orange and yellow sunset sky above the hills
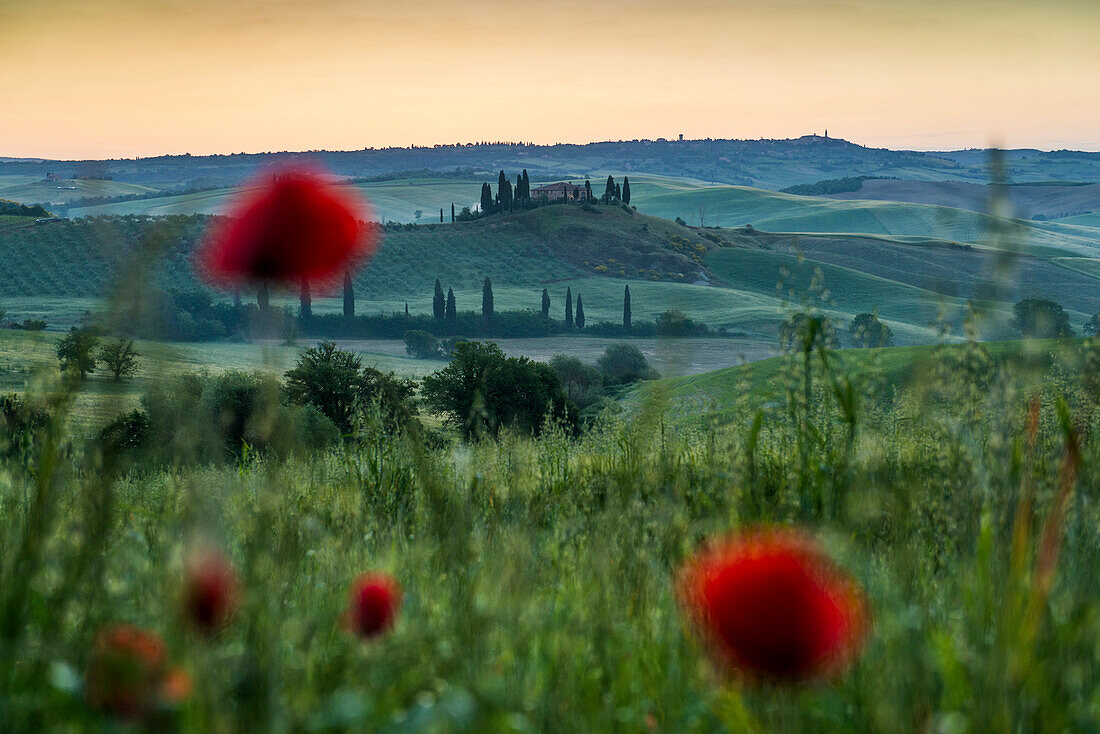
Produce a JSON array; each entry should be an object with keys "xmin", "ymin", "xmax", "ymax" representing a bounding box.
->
[{"xmin": 0, "ymin": 0, "xmax": 1100, "ymax": 158}]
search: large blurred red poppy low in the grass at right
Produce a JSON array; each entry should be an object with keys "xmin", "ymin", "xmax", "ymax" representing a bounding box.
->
[{"xmin": 680, "ymin": 530, "xmax": 866, "ymax": 681}]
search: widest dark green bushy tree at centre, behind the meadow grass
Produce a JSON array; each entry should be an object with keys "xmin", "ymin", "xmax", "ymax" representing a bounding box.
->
[{"xmin": 422, "ymin": 341, "xmax": 576, "ymax": 438}]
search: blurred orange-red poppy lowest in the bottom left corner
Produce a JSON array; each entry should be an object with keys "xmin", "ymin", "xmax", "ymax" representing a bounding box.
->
[{"xmin": 85, "ymin": 625, "xmax": 190, "ymax": 719}]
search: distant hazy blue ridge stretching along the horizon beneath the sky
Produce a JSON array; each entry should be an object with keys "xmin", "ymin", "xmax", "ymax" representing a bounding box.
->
[{"xmin": 0, "ymin": 135, "xmax": 1100, "ymax": 192}]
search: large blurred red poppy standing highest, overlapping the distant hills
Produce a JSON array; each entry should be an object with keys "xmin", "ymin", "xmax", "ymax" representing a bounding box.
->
[{"xmin": 199, "ymin": 169, "xmax": 380, "ymax": 285}]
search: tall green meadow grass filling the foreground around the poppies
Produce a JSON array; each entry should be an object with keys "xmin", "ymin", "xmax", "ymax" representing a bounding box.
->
[{"xmin": 0, "ymin": 332, "xmax": 1100, "ymax": 734}]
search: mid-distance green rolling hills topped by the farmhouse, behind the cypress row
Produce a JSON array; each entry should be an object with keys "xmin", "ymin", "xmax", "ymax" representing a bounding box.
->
[{"xmin": 0, "ymin": 203, "xmax": 1100, "ymax": 343}]
